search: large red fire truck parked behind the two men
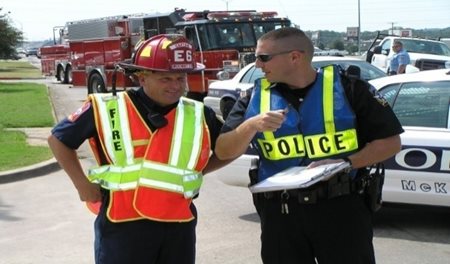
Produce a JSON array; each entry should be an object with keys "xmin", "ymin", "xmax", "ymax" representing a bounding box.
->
[{"xmin": 41, "ymin": 9, "xmax": 291, "ymax": 100}]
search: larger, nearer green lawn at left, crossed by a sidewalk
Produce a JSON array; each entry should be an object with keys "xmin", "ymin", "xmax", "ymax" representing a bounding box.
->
[{"xmin": 0, "ymin": 76, "xmax": 54, "ymax": 171}]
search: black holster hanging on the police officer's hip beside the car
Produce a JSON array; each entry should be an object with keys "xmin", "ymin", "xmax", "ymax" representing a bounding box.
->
[{"xmin": 363, "ymin": 163, "xmax": 384, "ymax": 212}]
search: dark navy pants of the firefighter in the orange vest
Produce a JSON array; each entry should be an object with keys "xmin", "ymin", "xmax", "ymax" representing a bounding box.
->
[{"xmin": 95, "ymin": 204, "xmax": 197, "ymax": 264}]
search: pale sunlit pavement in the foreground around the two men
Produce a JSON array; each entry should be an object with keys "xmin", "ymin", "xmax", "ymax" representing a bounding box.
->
[{"xmin": 0, "ymin": 75, "xmax": 450, "ymax": 264}]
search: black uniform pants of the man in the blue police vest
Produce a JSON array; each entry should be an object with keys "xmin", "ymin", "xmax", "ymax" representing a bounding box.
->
[{"xmin": 256, "ymin": 194, "xmax": 375, "ymax": 264}]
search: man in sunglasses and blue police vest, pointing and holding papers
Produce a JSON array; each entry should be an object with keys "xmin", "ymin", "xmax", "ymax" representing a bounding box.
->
[{"xmin": 216, "ymin": 28, "xmax": 403, "ymax": 264}]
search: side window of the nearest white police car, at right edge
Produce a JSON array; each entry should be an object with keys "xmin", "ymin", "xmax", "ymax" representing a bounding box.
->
[{"xmin": 386, "ymin": 81, "xmax": 450, "ymax": 128}]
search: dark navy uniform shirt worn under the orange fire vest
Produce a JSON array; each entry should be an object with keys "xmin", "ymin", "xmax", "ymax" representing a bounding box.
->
[{"xmin": 52, "ymin": 88, "xmax": 222, "ymax": 162}]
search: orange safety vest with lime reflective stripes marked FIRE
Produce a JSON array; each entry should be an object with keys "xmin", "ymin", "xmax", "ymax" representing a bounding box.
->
[{"xmin": 89, "ymin": 92, "xmax": 211, "ymax": 222}]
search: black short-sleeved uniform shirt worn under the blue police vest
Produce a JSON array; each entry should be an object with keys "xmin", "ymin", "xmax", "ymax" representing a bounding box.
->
[{"xmin": 221, "ymin": 74, "xmax": 403, "ymax": 151}]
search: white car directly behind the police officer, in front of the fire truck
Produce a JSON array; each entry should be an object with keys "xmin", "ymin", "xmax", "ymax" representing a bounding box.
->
[{"xmin": 204, "ymin": 56, "xmax": 386, "ymax": 118}]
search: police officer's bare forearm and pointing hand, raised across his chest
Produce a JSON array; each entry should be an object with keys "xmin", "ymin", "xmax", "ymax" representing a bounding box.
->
[{"xmin": 215, "ymin": 110, "xmax": 286, "ymax": 160}]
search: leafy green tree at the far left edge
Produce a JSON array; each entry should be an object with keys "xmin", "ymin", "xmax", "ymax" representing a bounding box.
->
[{"xmin": 0, "ymin": 8, "xmax": 23, "ymax": 59}]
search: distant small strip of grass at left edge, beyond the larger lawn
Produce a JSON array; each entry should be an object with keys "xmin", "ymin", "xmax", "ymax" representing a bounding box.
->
[{"xmin": 0, "ymin": 61, "xmax": 42, "ymax": 79}]
